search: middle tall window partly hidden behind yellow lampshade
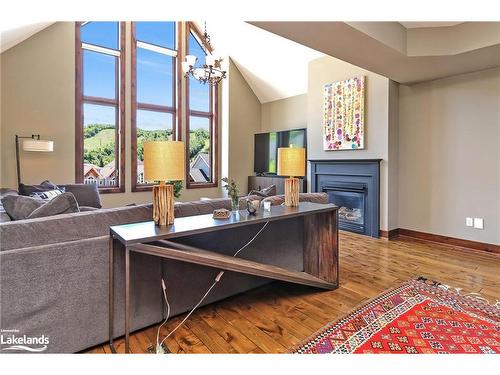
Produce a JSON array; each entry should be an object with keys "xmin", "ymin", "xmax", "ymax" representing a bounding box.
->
[{"xmin": 131, "ymin": 22, "xmax": 180, "ymax": 191}]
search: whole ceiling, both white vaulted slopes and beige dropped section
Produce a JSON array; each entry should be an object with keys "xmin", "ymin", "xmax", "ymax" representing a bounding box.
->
[{"xmin": 0, "ymin": 19, "xmax": 500, "ymax": 103}]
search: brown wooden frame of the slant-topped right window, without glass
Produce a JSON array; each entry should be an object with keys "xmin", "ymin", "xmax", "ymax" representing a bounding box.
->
[{"xmin": 184, "ymin": 22, "xmax": 219, "ymax": 189}]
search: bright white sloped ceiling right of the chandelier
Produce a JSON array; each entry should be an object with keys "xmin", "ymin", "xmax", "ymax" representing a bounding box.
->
[{"xmin": 207, "ymin": 20, "xmax": 324, "ymax": 103}]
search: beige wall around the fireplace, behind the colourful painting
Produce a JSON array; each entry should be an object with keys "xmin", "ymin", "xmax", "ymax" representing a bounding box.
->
[{"xmin": 262, "ymin": 56, "xmax": 398, "ymax": 229}]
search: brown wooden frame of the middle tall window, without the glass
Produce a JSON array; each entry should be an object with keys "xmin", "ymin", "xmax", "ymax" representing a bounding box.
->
[{"xmin": 130, "ymin": 22, "xmax": 183, "ymax": 192}]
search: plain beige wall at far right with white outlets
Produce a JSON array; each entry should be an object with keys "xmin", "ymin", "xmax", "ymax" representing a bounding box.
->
[{"xmin": 399, "ymin": 68, "xmax": 500, "ymax": 244}]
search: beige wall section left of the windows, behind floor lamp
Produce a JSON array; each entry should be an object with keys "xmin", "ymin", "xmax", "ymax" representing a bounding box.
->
[{"xmin": 0, "ymin": 22, "xmax": 75, "ymax": 188}]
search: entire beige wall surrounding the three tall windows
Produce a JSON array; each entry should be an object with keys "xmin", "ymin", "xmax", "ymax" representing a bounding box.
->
[{"xmin": 0, "ymin": 22, "xmax": 261, "ymax": 207}]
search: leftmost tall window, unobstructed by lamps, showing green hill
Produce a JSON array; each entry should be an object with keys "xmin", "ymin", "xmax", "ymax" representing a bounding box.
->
[{"xmin": 75, "ymin": 22, "xmax": 125, "ymax": 192}]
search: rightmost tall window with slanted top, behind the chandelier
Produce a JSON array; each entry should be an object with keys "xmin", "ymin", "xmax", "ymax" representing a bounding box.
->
[{"xmin": 186, "ymin": 23, "xmax": 218, "ymax": 188}]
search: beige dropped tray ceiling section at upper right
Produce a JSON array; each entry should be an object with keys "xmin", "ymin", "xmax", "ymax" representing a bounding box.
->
[{"xmin": 252, "ymin": 22, "xmax": 500, "ymax": 84}]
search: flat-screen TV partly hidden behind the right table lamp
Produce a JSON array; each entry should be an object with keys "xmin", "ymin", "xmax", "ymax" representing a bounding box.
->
[{"xmin": 253, "ymin": 129, "xmax": 307, "ymax": 175}]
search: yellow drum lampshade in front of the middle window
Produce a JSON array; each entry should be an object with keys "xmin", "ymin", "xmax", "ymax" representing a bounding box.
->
[{"xmin": 144, "ymin": 141, "xmax": 186, "ymax": 181}]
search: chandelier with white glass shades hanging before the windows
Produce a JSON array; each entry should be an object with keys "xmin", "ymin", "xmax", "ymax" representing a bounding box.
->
[{"xmin": 182, "ymin": 22, "xmax": 226, "ymax": 86}]
